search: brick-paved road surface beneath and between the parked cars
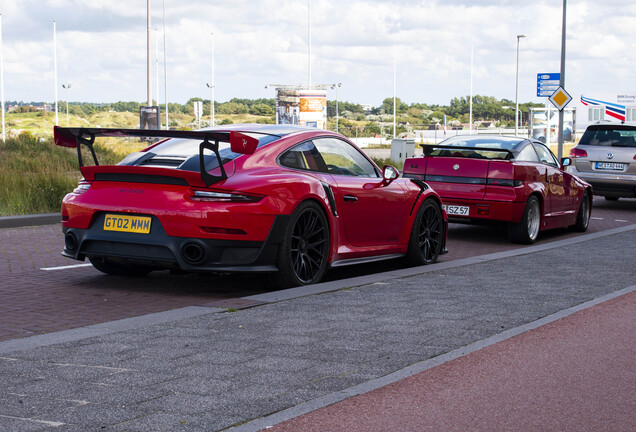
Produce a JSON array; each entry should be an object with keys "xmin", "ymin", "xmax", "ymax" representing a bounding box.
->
[{"xmin": 0, "ymin": 198, "xmax": 636, "ymax": 341}]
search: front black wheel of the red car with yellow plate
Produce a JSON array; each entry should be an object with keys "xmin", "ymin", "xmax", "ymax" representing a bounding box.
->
[{"xmin": 406, "ymin": 198, "xmax": 446, "ymax": 266}]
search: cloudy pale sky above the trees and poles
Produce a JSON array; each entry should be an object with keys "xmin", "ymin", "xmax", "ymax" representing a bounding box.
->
[{"xmin": 0, "ymin": 0, "xmax": 636, "ymax": 106}]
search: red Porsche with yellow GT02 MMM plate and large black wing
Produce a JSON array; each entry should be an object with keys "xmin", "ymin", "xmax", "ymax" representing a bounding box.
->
[{"xmin": 55, "ymin": 125, "xmax": 448, "ymax": 287}]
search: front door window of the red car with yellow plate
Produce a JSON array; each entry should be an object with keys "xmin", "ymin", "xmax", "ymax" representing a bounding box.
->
[{"xmin": 314, "ymin": 138, "xmax": 380, "ymax": 177}]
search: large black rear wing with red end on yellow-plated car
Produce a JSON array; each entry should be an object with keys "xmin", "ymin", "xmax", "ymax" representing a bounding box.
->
[{"xmin": 53, "ymin": 126, "xmax": 268, "ymax": 186}]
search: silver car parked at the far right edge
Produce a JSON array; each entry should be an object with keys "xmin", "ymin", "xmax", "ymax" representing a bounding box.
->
[{"xmin": 568, "ymin": 123, "xmax": 636, "ymax": 201}]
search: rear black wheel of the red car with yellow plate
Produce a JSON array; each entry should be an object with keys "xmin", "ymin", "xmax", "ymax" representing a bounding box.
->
[{"xmin": 269, "ymin": 201, "xmax": 329, "ymax": 289}]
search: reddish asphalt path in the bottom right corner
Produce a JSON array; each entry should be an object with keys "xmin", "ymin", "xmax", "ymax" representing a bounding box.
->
[{"xmin": 260, "ymin": 292, "xmax": 636, "ymax": 432}]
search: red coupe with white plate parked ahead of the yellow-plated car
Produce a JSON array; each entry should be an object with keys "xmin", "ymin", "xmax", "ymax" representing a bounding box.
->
[{"xmin": 404, "ymin": 135, "xmax": 592, "ymax": 244}]
